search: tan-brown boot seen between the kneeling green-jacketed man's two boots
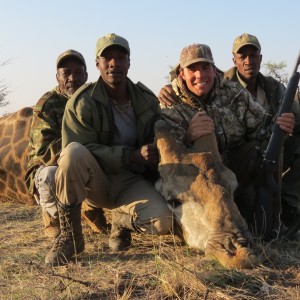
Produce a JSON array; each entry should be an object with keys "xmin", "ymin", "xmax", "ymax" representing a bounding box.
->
[{"xmin": 81, "ymin": 201, "xmax": 109, "ymax": 233}]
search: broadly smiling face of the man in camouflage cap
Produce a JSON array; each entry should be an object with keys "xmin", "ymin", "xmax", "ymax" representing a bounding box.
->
[{"xmin": 180, "ymin": 62, "xmax": 216, "ymax": 97}]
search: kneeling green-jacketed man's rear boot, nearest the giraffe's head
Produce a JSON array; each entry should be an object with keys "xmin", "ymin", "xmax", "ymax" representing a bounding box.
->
[{"xmin": 108, "ymin": 211, "xmax": 134, "ymax": 251}]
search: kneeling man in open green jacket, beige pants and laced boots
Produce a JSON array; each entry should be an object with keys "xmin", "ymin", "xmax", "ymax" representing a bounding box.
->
[{"xmin": 45, "ymin": 33, "xmax": 172, "ymax": 265}]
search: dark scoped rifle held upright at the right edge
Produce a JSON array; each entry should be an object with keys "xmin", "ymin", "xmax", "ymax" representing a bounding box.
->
[{"xmin": 254, "ymin": 52, "xmax": 300, "ymax": 241}]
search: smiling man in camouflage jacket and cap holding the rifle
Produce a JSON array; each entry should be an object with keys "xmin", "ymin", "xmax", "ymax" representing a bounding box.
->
[{"xmin": 158, "ymin": 44, "xmax": 294, "ymax": 239}]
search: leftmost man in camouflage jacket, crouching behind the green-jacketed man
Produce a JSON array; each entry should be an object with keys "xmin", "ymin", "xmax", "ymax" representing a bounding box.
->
[{"xmin": 25, "ymin": 49, "xmax": 106, "ymax": 238}]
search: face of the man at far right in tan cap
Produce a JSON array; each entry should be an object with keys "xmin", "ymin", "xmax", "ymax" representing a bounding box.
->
[{"xmin": 233, "ymin": 45, "xmax": 262, "ymax": 82}]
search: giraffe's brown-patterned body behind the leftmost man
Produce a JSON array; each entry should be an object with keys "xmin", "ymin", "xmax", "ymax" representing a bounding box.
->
[{"xmin": 0, "ymin": 107, "xmax": 35, "ymax": 204}]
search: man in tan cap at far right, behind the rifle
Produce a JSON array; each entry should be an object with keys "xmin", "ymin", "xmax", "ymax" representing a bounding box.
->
[{"xmin": 224, "ymin": 33, "xmax": 300, "ymax": 238}]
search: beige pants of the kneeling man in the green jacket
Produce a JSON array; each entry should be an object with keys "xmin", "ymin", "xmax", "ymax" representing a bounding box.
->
[{"xmin": 55, "ymin": 143, "xmax": 172, "ymax": 234}]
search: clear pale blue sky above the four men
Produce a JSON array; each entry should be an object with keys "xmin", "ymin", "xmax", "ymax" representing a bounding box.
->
[{"xmin": 0, "ymin": 0, "xmax": 300, "ymax": 115}]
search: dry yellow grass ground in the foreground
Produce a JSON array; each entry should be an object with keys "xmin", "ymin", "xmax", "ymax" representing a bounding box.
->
[{"xmin": 0, "ymin": 203, "xmax": 300, "ymax": 300}]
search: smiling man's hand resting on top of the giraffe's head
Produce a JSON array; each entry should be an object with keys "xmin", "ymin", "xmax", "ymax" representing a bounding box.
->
[{"xmin": 186, "ymin": 111, "xmax": 215, "ymax": 143}]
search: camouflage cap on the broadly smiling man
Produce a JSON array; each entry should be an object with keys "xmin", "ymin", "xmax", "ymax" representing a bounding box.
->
[{"xmin": 180, "ymin": 44, "xmax": 214, "ymax": 68}]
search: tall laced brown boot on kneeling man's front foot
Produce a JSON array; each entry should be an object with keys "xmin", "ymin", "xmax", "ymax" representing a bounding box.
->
[{"xmin": 45, "ymin": 202, "xmax": 84, "ymax": 266}]
